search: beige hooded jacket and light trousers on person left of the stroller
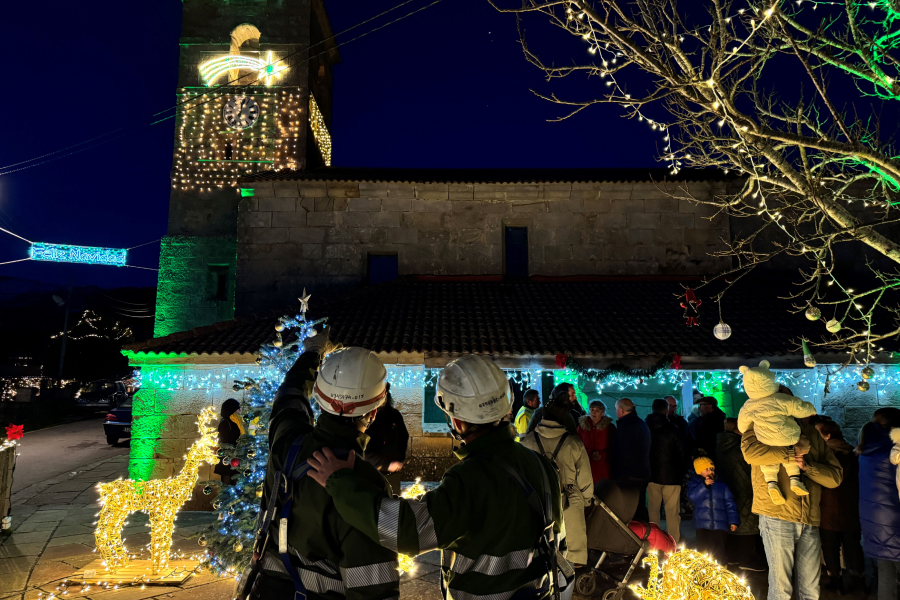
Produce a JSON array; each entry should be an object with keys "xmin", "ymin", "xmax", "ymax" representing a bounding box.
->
[{"xmin": 522, "ymin": 419, "xmax": 594, "ymax": 565}]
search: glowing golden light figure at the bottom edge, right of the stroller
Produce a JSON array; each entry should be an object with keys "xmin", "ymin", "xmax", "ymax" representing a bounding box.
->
[{"xmin": 630, "ymin": 549, "xmax": 753, "ymax": 600}]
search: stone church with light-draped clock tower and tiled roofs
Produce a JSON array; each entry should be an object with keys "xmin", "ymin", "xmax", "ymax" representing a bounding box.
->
[{"xmin": 123, "ymin": 0, "xmax": 898, "ymax": 479}]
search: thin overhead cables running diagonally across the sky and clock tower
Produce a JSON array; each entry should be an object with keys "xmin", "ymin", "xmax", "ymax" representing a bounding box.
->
[{"xmin": 0, "ymin": 0, "xmax": 442, "ymax": 177}]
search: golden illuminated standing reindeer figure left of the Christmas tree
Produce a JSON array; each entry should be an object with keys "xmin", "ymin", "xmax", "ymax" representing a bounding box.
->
[{"xmin": 94, "ymin": 406, "xmax": 218, "ymax": 575}]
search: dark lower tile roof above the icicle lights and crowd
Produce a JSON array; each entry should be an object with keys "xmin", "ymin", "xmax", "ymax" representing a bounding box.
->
[{"xmin": 125, "ymin": 280, "xmax": 856, "ymax": 359}]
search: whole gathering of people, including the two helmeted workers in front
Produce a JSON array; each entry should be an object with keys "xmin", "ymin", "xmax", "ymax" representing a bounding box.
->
[{"xmin": 217, "ymin": 336, "xmax": 900, "ymax": 600}]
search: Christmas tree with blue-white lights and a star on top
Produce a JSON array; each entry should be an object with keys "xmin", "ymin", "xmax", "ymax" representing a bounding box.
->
[{"xmin": 198, "ymin": 302, "xmax": 324, "ymax": 574}]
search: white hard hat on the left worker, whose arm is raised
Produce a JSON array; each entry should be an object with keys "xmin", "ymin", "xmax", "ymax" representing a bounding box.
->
[{"xmin": 312, "ymin": 346, "xmax": 387, "ymax": 417}]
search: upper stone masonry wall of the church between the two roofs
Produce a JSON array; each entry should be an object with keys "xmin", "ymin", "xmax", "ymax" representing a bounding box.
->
[{"xmin": 236, "ymin": 181, "xmax": 729, "ymax": 314}]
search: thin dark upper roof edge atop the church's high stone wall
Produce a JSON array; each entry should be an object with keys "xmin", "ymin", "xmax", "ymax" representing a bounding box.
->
[{"xmin": 240, "ymin": 167, "xmax": 729, "ymax": 184}]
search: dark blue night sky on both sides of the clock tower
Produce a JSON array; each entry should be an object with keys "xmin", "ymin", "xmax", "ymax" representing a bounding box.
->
[{"xmin": 0, "ymin": 0, "xmax": 661, "ymax": 287}]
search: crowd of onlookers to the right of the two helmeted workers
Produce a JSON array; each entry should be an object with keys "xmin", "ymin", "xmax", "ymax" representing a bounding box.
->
[{"xmin": 515, "ymin": 364, "xmax": 900, "ymax": 600}]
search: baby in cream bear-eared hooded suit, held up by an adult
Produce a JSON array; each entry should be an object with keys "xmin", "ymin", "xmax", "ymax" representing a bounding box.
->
[{"xmin": 738, "ymin": 360, "xmax": 816, "ymax": 505}]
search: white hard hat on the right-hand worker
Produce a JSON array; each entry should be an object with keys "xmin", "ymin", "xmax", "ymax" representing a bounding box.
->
[{"xmin": 434, "ymin": 354, "xmax": 512, "ymax": 425}]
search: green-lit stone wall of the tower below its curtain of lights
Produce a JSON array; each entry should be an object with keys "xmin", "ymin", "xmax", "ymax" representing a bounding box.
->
[{"xmin": 153, "ymin": 236, "xmax": 237, "ymax": 337}]
